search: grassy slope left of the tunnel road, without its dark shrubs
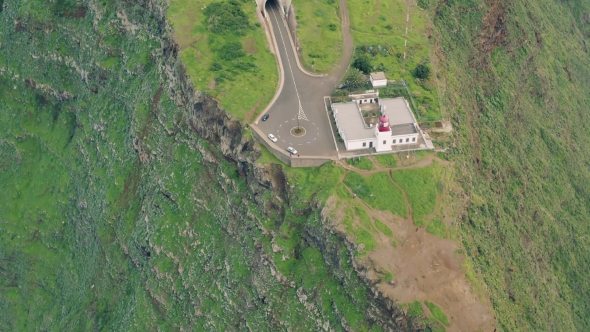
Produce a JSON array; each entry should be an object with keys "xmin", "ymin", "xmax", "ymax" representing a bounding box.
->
[{"xmin": 168, "ymin": 0, "xmax": 278, "ymax": 121}]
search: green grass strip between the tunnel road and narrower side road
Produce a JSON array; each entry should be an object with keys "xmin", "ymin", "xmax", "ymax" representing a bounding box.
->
[{"xmin": 293, "ymin": 0, "xmax": 343, "ymax": 72}]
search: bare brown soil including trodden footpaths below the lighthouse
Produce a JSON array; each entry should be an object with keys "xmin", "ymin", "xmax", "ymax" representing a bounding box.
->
[{"xmin": 330, "ymin": 155, "xmax": 496, "ymax": 332}]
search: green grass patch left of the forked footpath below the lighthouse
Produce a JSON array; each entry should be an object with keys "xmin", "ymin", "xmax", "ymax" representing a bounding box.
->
[{"xmin": 344, "ymin": 172, "xmax": 408, "ymax": 217}]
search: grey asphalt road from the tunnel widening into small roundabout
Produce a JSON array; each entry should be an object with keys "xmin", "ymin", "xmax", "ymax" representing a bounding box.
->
[{"xmin": 257, "ymin": 0, "xmax": 341, "ymax": 156}]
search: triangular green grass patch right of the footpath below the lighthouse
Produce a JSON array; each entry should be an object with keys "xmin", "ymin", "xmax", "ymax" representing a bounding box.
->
[{"xmin": 392, "ymin": 162, "xmax": 443, "ymax": 224}]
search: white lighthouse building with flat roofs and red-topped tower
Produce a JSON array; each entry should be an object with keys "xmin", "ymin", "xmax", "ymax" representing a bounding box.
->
[{"xmin": 332, "ymin": 93, "xmax": 419, "ymax": 152}]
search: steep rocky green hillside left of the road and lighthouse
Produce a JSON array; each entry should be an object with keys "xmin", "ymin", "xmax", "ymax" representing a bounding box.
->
[{"xmin": 0, "ymin": 0, "xmax": 416, "ymax": 331}]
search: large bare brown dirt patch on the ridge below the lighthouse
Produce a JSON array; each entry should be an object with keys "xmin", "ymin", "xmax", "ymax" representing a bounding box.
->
[{"xmin": 369, "ymin": 217, "xmax": 496, "ymax": 331}]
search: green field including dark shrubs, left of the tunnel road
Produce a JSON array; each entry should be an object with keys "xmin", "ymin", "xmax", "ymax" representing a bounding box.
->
[{"xmin": 167, "ymin": 0, "xmax": 278, "ymax": 122}]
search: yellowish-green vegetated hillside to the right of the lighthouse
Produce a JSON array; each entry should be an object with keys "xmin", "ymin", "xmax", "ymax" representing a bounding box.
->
[{"xmin": 418, "ymin": 0, "xmax": 590, "ymax": 331}]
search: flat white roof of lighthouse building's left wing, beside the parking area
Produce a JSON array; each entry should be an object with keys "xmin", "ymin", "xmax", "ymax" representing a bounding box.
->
[{"xmin": 332, "ymin": 102, "xmax": 375, "ymax": 141}]
